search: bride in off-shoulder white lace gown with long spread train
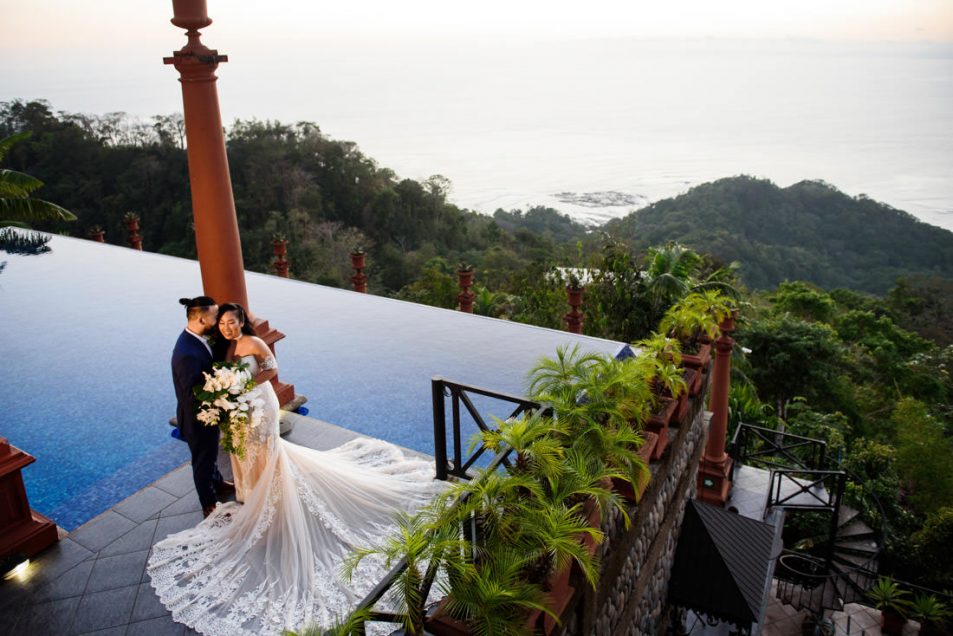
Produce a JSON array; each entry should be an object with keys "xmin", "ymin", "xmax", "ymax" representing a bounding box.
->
[{"xmin": 147, "ymin": 304, "xmax": 441, "ymax": 636}]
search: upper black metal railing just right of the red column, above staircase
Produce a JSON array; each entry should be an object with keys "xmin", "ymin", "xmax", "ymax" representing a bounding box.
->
[{"xmin": 729, "ymin": 423, "xmax": 827, "ymax": 470}]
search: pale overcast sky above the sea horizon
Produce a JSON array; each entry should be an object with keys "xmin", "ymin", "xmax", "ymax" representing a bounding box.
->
[{"xmin": 0, "ymin": 0, "xmax": 953, "ymax": 57}]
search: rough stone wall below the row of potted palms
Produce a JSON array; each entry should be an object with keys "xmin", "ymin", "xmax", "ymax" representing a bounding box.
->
[{"xmin": 554, "ymin": 391, "xmax": 710, "ymax": 636}]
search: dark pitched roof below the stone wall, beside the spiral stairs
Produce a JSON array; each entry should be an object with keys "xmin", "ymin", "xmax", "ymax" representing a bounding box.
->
[{"xmin": 668, "ymin": 500, "xmax": 774, "ymax": 625}]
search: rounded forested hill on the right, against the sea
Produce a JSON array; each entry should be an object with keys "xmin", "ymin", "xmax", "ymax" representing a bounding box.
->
[{"xmin": 606, "ymin": 177, "xmax": 953, "ymax": 293}]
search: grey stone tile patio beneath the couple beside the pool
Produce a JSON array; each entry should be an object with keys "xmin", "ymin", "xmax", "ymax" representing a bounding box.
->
[{"xmin": 0, "ymin": 413, "xmax": 420, "ymax": 636}]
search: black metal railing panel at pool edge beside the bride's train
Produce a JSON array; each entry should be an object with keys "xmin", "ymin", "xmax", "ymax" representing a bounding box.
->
[{"xmin": 431, "ymin": 377, "xmax": 543, "ymax": 480}]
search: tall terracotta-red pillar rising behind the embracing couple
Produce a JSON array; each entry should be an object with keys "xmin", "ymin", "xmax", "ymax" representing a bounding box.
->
[{"xmin": 163, "ymin": 0, "xmax": 294, "ymax": 405}]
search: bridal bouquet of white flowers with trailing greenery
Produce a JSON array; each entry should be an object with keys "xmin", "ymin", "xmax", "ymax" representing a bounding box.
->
[{"xmin": 193, "ymin": 362, "xmax": 264, "ymax": 459}]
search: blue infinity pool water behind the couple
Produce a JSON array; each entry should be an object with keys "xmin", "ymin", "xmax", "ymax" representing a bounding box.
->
[{"xmin": 0, "ymin": 231, "xmax": 624, "ymax": 530}]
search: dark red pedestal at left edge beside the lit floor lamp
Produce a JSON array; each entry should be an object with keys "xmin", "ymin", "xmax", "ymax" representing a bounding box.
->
[{"xmin": 0, "ymin": 438, "xmax": 59, "ymax": 557}]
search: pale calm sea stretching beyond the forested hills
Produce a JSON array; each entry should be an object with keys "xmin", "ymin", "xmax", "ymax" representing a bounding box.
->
[{"xmin": 7, "ymin": 35, "xmax": 953, "ymax": 229}]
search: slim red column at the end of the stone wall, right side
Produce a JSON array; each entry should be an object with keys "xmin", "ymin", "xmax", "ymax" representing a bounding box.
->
[{"xmin": 698, "ymin": 316, "xmax": 735, "ymax": 506}]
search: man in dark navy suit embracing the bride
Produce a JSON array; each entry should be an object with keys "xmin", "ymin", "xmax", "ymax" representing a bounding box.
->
[{"xmin": 172, "ymin": 296, "xmax": 235, "ymax": 517}]
